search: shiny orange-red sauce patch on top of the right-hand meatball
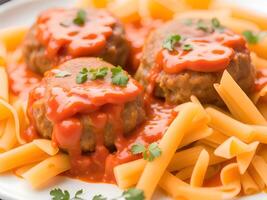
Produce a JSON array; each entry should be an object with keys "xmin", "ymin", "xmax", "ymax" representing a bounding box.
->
[{"xmin": 156, "ymin": 22, "xmax": 246, "ymax": 74}]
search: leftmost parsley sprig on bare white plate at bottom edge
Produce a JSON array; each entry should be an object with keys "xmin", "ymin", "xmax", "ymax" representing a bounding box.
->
[{"xmin": 50, "ymin": 188, "xmax": 83, "ymax": 200}]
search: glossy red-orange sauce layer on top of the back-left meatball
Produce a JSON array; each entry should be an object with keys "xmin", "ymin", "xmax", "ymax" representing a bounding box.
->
[{"xmin": 36, "ymin": 9, "xmax": 116, "ymax": 63}]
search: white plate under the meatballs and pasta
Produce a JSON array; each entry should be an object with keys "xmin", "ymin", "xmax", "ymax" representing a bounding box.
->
[{"xmin": 0, "ymin": 0, "xmax": 267, "ymax": 200}]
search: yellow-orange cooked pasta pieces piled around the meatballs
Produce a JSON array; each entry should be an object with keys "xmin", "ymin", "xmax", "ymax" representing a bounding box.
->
[{"xmin": 0, "ymin": 0, "xmax": 267, "ymax": 200}]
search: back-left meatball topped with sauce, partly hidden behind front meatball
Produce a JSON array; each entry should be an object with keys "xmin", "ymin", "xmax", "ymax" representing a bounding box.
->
[{"xmin": 22, "ymin": 9, "xmax": 129, "ymax": 74}]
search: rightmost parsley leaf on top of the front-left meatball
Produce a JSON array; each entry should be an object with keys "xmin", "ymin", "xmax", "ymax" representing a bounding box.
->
[{"xmin": 111, "ymin": 66, "xmax": 129, "ymax": 86}]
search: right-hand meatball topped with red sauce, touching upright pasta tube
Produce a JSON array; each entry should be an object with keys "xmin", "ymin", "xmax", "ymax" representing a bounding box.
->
[{"xmin": 135, "ymin": 19, "xmax": 255, "ymax": 105}]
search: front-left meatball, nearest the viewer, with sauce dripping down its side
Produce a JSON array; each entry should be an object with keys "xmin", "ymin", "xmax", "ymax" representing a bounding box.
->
[{"xmin": 27, "ymin": 58, "xmax": 145, "ymax": 152}]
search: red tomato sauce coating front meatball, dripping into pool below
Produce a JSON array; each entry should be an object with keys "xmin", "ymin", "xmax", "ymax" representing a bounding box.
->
[{"xmin": 23, "ymin": 62, "xmax": 176, "ymax": 183}]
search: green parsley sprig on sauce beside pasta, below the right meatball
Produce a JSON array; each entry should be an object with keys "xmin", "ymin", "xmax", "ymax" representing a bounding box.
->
[{"xmin": 131, "ymin": 142, "xmax": 161, "ymax": 161}]
